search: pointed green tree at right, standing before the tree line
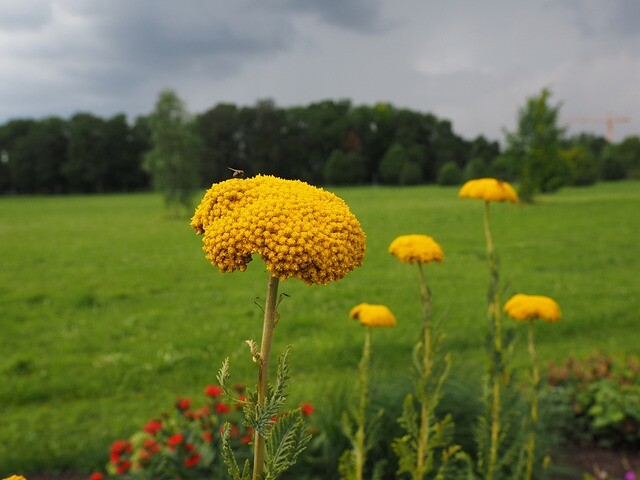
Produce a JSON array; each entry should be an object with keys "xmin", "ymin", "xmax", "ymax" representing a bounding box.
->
[{"xmin": 505, "ymin": 88, "xmax": 570, "ymax": 201}]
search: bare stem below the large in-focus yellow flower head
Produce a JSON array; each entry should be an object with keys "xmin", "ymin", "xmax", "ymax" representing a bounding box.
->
[{"xmin": 253, "ymin": 276, "xmax": 278, "ymax": 480}]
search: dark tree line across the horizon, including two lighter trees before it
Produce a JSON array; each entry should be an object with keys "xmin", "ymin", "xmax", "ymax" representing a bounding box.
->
[{"xmin": 0, "ymin": 90, "xmax": 640, "ymax": 201}]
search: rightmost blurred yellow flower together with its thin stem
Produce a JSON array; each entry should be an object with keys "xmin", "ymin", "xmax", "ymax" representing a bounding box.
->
[{"xmin": 504, "ymin": 293, "xmax": 562, "ymax": 480}]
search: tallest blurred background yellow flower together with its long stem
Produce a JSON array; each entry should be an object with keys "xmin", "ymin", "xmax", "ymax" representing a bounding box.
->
[{"xmin": 459, "ymin": 178, "xmax": 518, "ymax": 480}]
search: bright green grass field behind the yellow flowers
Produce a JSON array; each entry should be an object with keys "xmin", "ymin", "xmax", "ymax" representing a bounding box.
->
[{"xmin": 0, "ymin": 182, "xmax": 640, "ymax": 476}]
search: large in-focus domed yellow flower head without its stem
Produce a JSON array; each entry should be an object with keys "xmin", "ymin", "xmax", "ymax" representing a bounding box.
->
[{"xmin": 191, "ymin": 175, "xmax": 366, "ymax": 285}]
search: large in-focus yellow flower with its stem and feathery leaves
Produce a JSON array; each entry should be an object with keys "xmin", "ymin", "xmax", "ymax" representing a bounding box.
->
[{"xmin": 191, "ymin": 175, "xmax": 365, "ymax": 480}]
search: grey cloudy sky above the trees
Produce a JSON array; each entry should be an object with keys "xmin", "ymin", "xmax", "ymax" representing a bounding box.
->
[{"xmin": 0, "ymin": 0, "xmax": 640, "ymax": 141}]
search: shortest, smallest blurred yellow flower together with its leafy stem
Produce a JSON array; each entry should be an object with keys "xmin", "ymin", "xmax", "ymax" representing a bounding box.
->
[{"xmin": 339, "ymin": 303, "xmax": 396, "ymax": 480}]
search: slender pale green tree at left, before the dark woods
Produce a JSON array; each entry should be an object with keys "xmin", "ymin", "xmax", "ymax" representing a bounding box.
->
[{"xmin": 144, "ymin": 89, "xmax": 202, "ymax": 216}]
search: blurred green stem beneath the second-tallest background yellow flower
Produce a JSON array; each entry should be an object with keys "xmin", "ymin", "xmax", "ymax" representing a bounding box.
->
[{"xmin": 413, "ymin": 263, "xmax": 432, "ymax": 480}]
